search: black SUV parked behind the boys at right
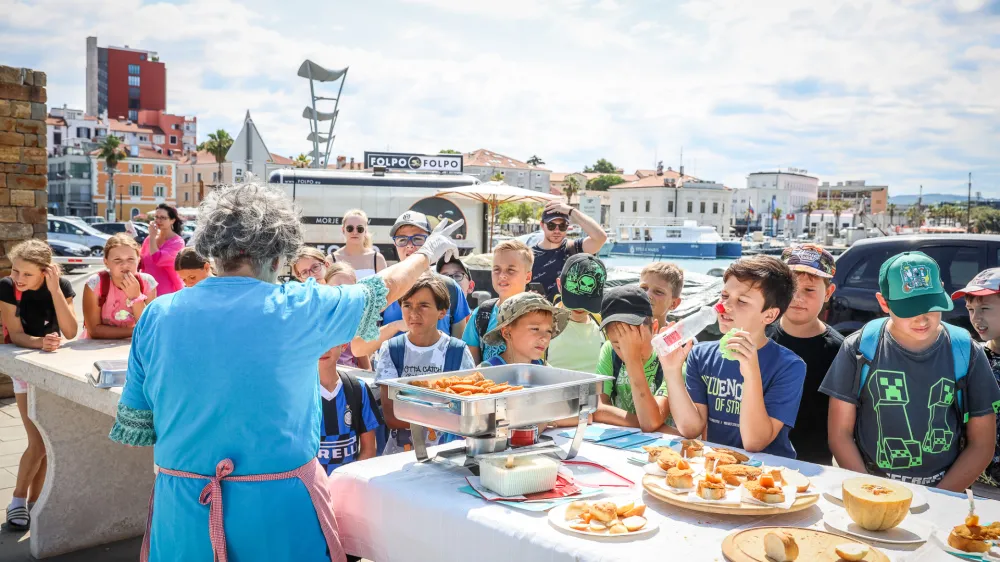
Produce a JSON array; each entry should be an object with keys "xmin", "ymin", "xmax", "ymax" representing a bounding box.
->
[{"xmin": 826, "ymin": 234, "xmax": 1000, "ymax": 335}]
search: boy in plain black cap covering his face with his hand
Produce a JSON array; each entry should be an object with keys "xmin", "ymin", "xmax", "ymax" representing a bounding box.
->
[{"xmin": 594, "ymin": 285, "xmax": 670, "ymax": 431}]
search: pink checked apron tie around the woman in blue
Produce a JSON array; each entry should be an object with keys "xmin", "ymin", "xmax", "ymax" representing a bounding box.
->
[{"xmin": 139, "ymin": 459, "xmax": 346, "ymax": 562}]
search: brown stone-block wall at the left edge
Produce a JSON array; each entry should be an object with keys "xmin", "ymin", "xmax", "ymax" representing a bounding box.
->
[{"xmin": 0, "ymin": 65, "xmax": 48, "ymax": 397}]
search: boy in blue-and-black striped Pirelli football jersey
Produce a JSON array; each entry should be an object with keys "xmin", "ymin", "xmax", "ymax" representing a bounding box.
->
[{"xmin": 317, "ymin": 345, "xmax": 385, "ymax": 474}]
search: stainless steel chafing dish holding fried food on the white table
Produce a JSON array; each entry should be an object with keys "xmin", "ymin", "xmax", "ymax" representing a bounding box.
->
[{"xmin": 379, "ymin": 365, "xmax": 611, "ymax": 462}]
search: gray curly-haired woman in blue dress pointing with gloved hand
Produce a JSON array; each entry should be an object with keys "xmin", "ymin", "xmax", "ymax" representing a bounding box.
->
[{"xmin": 110, "ymin": 183, "xmax": 460, "ymax": 562}]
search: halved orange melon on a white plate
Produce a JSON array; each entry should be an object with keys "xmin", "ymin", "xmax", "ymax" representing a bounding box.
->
[{"xmin": 843, "ymin": 477, "xmax": 913, "ymax": 531}]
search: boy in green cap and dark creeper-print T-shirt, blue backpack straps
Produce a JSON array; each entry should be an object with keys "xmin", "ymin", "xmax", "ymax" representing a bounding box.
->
[{"xmin": 820, "ymin": 252, "xmax": 1000, "ymax": 492}]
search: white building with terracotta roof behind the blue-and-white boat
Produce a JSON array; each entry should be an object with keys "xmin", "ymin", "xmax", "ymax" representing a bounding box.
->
[{"xmin": 609, "ymin": 169, "xmax": 732, "ymax": 236}]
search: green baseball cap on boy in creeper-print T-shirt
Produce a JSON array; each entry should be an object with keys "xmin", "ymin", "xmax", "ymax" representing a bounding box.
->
[{"xmin": 878, "ymin": 252, "xmax": 955, "ymax": 318}]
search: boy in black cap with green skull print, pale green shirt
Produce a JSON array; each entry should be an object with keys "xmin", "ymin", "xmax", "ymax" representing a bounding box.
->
[{"xmin": 548, "ymin": 254, "xmax": 608, "ymax": 373}]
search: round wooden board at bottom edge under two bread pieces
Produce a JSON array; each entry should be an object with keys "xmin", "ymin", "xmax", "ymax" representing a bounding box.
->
[{"xmin": 722, "ymin": 527, "xmax": 889, "ymax": 562}]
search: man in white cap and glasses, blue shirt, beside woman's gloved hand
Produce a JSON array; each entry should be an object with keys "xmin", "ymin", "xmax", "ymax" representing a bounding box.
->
[{"xmin": 382, "ymin": 211, "xmax": 472, "ymax": 338}]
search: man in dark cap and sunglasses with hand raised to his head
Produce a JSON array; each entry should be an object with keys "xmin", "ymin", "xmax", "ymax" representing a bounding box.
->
[{"xmin": 531, "ymin": 201, "xmax": 608, "ymax": 300}]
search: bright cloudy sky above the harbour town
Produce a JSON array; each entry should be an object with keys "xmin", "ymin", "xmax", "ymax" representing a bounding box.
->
[{"xmin": 0, "ymin": 0, "xmax": 1000, "ymax": 197}]
